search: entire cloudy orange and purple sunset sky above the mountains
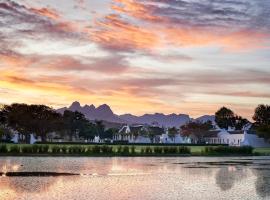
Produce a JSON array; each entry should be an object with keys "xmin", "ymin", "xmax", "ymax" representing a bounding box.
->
[{"xmin": 0, "ymin": 0, "xmax": 270, "ymax": 119}]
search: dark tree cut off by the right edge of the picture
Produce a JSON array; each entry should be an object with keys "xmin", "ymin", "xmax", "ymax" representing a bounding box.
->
[{"xmin": 253, "ymin": 105, "xmax": 270, "ymax": 140}]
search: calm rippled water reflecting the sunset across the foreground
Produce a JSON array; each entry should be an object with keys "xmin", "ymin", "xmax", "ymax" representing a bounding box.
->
[{"xmin": 0, "ymin": 157, "xmax": 270, "ymax": 200}]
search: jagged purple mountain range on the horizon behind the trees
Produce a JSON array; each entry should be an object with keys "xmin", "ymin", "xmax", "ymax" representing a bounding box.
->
[{"xmin": 57, "ymin": 101, "xmax": 215, "ymax": 127}]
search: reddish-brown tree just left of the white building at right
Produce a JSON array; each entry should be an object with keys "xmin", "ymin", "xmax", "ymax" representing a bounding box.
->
[{"xmin": 181, "ymin": 121, "xmax": 213, "ymax": 141}]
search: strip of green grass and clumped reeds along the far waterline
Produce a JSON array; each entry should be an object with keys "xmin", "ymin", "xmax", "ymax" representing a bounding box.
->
[{"xmin": 0, "ymin": 144, "xmax": 270, "ymax": 156}]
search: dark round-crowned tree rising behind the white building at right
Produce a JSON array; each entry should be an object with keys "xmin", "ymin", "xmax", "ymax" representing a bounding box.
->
[{"xmin": 215, "ymin": 107, "xmax": 235, "ymax": 129}]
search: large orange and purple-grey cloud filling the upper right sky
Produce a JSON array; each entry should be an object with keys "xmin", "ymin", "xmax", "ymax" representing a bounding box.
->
[{"xmin": 92, "ymin": 0, "xmax": 270, "ymax": 51}]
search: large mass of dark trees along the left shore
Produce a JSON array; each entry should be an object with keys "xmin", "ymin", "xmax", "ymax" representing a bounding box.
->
[{"xmin": 0, "ymin": 103, "xmax": 115, "ymax": 143}]
